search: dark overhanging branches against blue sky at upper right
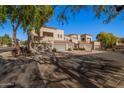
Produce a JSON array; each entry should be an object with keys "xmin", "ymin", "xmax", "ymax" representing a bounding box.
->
[{"xmin": 57, "ymin": 5, "xmax": 124, "ymax": 24}]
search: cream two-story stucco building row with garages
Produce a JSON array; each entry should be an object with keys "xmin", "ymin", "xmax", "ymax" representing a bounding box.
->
[{"xmin": 33, "ymin": 27, "xmax": 92, "ymax": 51}]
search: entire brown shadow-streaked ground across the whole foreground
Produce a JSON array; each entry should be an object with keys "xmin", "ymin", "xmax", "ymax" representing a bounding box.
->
[{"xmin": 0, "ymin": 51, "xmax": 124, "ymax": 88}]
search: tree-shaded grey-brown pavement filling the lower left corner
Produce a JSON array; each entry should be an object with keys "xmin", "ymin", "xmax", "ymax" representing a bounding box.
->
[{"xmin": 0, "ymin": 58, "xmax": 43, "ymax": 87}]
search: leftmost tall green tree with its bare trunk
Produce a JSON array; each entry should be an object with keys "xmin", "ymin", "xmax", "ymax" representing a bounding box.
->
[{"xmin": 0, "ymin": 5, "xmax": 22, "ymax": 54}]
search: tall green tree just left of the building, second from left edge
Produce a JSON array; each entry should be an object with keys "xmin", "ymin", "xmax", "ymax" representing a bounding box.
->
[{"xmin": 21, "ymin": 6, "xmax": 53, "ymax": 51}]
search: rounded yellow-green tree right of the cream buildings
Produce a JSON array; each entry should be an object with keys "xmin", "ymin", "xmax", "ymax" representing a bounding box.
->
[{"xmin": 96, "ymin": 32, "xmax": 118, "ymax": 48}]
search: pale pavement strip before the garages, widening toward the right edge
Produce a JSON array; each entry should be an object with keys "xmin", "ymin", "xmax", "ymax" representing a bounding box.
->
[{"xmin": 65, "ymin": 50, "xmax": 124, "ymax": 62}]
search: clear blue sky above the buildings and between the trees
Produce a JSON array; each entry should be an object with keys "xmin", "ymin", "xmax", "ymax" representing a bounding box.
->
[{"xmin": 0, "ymin": 5, "xmax": 124, "ymax": 40}]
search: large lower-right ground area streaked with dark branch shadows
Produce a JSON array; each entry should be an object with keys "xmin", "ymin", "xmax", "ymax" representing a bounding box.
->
[{"xmin": 39, "ymin": 53, "xmax": 124, "ymax": 88}]
